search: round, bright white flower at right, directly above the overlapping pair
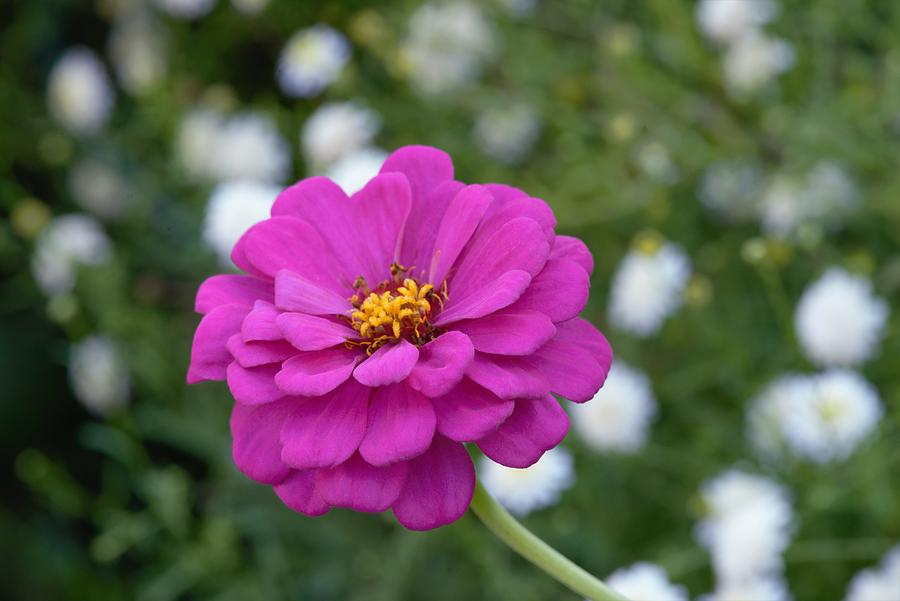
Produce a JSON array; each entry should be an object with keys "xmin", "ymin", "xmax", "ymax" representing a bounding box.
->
[{"xmin": 794, "ymin": 268, "xmax": 888, "ymax": 366}]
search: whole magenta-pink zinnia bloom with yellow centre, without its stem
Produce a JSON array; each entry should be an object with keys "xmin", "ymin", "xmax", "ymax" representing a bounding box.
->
[{"xmin": 188, "ymin": 146, "xmax": 612, "ymax": 530}]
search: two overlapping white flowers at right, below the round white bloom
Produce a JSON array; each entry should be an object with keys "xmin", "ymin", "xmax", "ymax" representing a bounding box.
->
[{"xmin": 748, "ymin": 370, "xmax": 883, "ymax": 463}]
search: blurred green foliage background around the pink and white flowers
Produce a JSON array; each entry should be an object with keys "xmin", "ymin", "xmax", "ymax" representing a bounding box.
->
[{"xmin": 0, "ymin": 0, "xmax": 900, "ymax": 601}]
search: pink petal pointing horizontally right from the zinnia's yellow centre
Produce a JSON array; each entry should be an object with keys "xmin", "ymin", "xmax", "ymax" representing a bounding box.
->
[{"xmin": 453, "ymin": 307, "xmax": 556, "ymax": 355}]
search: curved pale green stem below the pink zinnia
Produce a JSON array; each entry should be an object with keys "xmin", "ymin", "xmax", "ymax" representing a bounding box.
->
[{"xmin": 471, "ymin": 481, "xmax": 627, "ymax": 601}]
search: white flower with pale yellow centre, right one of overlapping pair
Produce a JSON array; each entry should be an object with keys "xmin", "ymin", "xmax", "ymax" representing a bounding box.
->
[{"xmin": 783, "ymin": 370, "xmax": 882, "ymax": 463}]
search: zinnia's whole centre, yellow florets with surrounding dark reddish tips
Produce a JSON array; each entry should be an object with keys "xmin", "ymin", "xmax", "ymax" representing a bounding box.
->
[{"xmin": 348, "ymin": 264, "xmax": 447, "ymax": 355}]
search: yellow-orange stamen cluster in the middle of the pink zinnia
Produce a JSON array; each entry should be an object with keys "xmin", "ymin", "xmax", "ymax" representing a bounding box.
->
[{"xmin": 350, "ymin": 278, "xmax": 434, "ymax": 354}]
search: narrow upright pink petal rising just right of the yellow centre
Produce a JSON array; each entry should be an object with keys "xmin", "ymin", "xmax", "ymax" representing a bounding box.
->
[{"xmin": 423, "ymin": 185, "xmax": 493, "ymax": 286}]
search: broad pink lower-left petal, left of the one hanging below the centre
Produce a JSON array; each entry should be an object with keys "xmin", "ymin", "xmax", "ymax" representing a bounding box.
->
[{"xmin": 281, "ymin": 380, "xmax": 371, "ymax": 469}]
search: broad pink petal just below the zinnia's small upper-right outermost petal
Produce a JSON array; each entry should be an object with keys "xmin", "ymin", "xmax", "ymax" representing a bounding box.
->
[{"xmin": 511, "ymin": 259, "xmax": 591, "ymax": 323}]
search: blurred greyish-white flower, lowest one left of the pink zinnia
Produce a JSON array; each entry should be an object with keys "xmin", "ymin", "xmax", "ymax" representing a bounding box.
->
[{"xmin": 69, "ymin": 336, "xmax": 131, "ymax": 415}]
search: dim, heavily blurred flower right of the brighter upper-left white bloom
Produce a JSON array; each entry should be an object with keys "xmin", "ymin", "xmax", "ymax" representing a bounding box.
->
[{"xmin": 108, "ymin": 14, "xmax": 167, "ymax": 94}]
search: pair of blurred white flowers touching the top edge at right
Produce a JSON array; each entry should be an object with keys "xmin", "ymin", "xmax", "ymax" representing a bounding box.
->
[{"xmin": 696, "ymin": 0, "xmax": 794, "ymax": 95}]
